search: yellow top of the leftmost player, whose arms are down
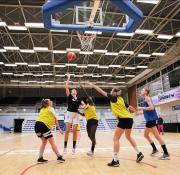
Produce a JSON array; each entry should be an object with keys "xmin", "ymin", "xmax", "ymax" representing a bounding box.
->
[{"xmin": 36, "ymin": 107, "xmax": 56, "ymax": 129}]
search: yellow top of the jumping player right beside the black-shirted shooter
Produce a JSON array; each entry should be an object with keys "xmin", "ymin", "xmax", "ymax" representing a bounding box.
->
[{"xmin": 84, "ymin": 104, "xmax": 99, "ymax": 121}]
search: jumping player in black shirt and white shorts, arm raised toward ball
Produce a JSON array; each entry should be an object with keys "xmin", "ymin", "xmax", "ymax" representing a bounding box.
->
[{"xmin": 64, "ymin": 74, "xmax": 81, "ymax": 154}]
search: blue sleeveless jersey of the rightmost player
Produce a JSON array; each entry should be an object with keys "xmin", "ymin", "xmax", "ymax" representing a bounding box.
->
[{"xmin": 143, "ymin": 98, "xmax": 158, "ymax": 121}]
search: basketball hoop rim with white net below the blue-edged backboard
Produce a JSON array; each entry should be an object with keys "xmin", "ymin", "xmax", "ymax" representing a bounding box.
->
[{"xmin": 77, "ymin": 31, "xmax": 96, "ymax": 51}]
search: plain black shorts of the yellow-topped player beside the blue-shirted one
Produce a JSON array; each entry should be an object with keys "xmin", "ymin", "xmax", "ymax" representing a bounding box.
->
[{"xmin": 117, "ymin": 118, "xmax": 133, "ymax": 129}]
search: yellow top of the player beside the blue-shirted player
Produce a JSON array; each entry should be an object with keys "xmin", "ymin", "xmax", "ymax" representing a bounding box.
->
[{"xmin": 111, "ymin": 97, "xmax": 133, "ymax": 118}]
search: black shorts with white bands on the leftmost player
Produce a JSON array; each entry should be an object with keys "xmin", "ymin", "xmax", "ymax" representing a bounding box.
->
[{"xmin": 34, "ymin": 122, "xmax": 53, "ymax": 139}]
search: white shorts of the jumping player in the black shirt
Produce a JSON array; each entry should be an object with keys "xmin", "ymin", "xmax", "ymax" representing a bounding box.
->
[{"xmin": 64, "ymin": 111, "xmax": 79, "ymax": 125}]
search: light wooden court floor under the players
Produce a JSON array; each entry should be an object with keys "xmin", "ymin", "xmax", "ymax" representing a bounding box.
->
[{"xmin": 0, "ymin": 131, "xmax": 180, "ymax": 175}]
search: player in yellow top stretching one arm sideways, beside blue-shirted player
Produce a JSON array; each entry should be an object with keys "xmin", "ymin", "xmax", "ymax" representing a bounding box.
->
[{"xmin": 87, "ymin": 82, "xmax": 144, "ymax": 167}]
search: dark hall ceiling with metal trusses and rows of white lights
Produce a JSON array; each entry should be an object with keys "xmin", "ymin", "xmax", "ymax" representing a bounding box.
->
[{"xmin": 0, "ymin": 0, "xmax": 180, "ymax": 87}]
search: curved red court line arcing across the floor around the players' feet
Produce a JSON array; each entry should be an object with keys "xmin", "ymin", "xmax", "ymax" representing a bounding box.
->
[{"xmin": 20, "ymin": 156, "xmax": 158, "ymax": 175}]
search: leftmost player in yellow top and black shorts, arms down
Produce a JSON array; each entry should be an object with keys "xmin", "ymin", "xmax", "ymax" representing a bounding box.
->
[{"xmin": 35, "ymin": 99, "xmax": 65, "ymax": 163}]
